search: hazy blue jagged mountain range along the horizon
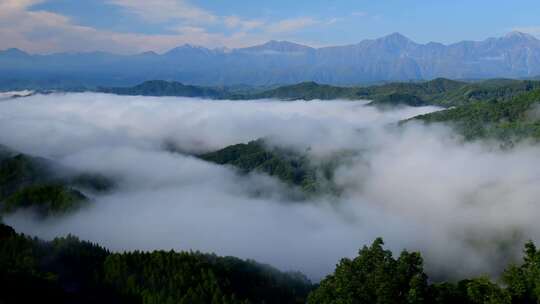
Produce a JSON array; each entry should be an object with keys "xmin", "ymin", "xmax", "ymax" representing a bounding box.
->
[{"xmin": 0, "ymin": 32, "xmax": 540, "ymax": 89}]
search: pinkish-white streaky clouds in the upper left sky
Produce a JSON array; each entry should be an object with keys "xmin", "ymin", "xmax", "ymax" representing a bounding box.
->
[{"xmin": 0, "ymin": 0, "xmax": 316, "ymax": 54}]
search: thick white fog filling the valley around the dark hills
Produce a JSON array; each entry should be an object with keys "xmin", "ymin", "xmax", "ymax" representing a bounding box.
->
[{"xmin": 0, "ymin": 93, "xmax": 540, "ymax": 281}]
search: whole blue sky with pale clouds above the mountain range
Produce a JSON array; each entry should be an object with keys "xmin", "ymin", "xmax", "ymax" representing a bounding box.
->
[{"xmin": 0, "ymin": 0, "xmax": 540, "ymax": 54}]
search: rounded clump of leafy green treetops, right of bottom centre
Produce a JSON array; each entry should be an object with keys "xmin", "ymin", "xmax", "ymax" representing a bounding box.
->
[{"xmin": 308, "ymin": 238, "xmax": 428, "ymax": 304}]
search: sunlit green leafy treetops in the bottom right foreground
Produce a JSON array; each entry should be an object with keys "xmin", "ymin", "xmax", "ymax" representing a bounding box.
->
[{"xmin": 308, "ymin": 239, "xmax": 540, "ymax": 304}]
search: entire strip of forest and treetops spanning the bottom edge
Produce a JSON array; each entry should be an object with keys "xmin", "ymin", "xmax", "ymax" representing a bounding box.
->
[{"xmin": 0, "ymin": 223, "xmax": 540, "ymax": 304}]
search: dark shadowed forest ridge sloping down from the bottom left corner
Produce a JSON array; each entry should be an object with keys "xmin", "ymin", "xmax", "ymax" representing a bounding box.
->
[{"xmin": 0, "ymin": 224, "xmax": 312, "ymax": 304}]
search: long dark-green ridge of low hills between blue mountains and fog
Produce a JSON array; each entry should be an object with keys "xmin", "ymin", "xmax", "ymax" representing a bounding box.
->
[{"xmin": 98, "ymin": 78, "xmax": 540, "ymax": 107}]
